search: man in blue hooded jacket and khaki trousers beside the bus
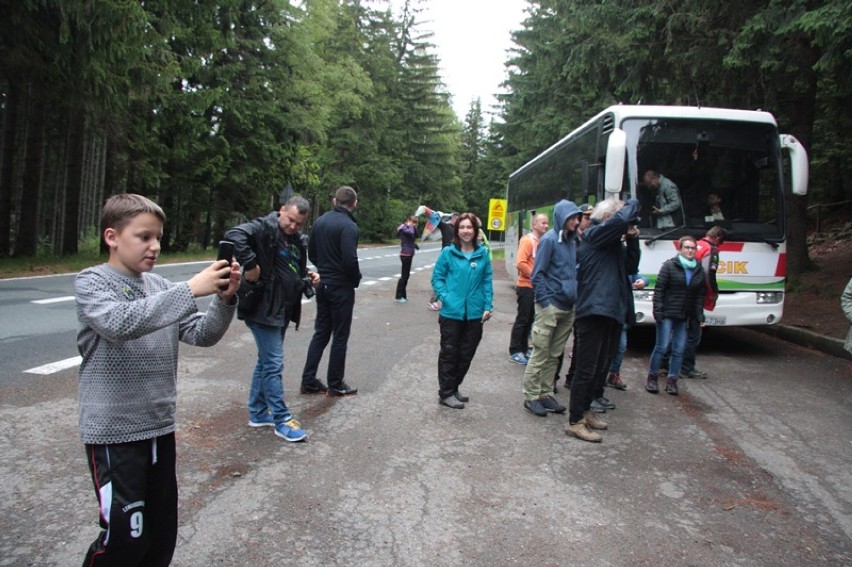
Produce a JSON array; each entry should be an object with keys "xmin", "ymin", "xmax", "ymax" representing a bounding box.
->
[{"xmin": 524, "ymin": 199, "xmax": 581, "ymax": 417}]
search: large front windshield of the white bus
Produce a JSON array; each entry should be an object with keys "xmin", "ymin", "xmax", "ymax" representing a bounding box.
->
[{"xmin": 621, "ymin": 118, "xmax": 785, "ymax": 243}]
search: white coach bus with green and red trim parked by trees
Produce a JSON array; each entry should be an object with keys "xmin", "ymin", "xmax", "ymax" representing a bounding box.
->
[{"xmin": 506, "ymin": 105, "xmax": 808, "ymax": 326}]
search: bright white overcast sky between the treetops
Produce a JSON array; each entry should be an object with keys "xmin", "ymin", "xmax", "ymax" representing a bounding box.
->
[{"xmin": 392, "ymin": 0, "xmax": 527, "ymax": 123}]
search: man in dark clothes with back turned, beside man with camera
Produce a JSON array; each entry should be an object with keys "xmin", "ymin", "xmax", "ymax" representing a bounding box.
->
[{"xmin": 301, "ymin": 185, "xmax": 361, "ymax": 396}]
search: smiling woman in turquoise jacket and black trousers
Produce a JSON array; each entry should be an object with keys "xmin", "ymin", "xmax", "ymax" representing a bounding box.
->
[{"xmin": 432, "ymin": 213, "xmax": 494, "ymax": 409}]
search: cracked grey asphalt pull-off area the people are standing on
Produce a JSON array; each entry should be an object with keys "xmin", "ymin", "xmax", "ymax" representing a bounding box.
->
[{"xmin": 0, "ymin": 254, "xmax": 852, "ymax": 566}]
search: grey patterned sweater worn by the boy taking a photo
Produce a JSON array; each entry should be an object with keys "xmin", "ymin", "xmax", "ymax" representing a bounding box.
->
[{"xmin": 74, "ymin": 264, "xmax": 236, "ymax": 445}]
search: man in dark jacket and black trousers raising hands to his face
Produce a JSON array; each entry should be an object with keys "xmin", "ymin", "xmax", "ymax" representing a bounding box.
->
[{"xmin": 566, "ymin": 199, "xmax": 639, "ymax": 442}]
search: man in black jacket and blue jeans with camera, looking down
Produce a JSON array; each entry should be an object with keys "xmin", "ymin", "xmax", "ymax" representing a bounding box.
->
[{"xmin": 225, "ymin": 195, "xmax": 319, "ymax": 441}]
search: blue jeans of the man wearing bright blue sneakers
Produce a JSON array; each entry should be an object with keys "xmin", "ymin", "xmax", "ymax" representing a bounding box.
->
[{"xmin": 246, "ymin": 321, "xmax": 293, "ymax": 425}]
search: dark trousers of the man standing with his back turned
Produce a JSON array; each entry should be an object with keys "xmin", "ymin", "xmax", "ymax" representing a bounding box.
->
[{"xmin": 302, "ymin": 284, "xmax": 355, "ymax": 388}]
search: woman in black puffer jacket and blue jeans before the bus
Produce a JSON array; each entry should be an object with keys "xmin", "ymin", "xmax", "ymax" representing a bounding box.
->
[{"xmin": 645, "ymin": 236, "xmax": 706, "ymax": 395}]
